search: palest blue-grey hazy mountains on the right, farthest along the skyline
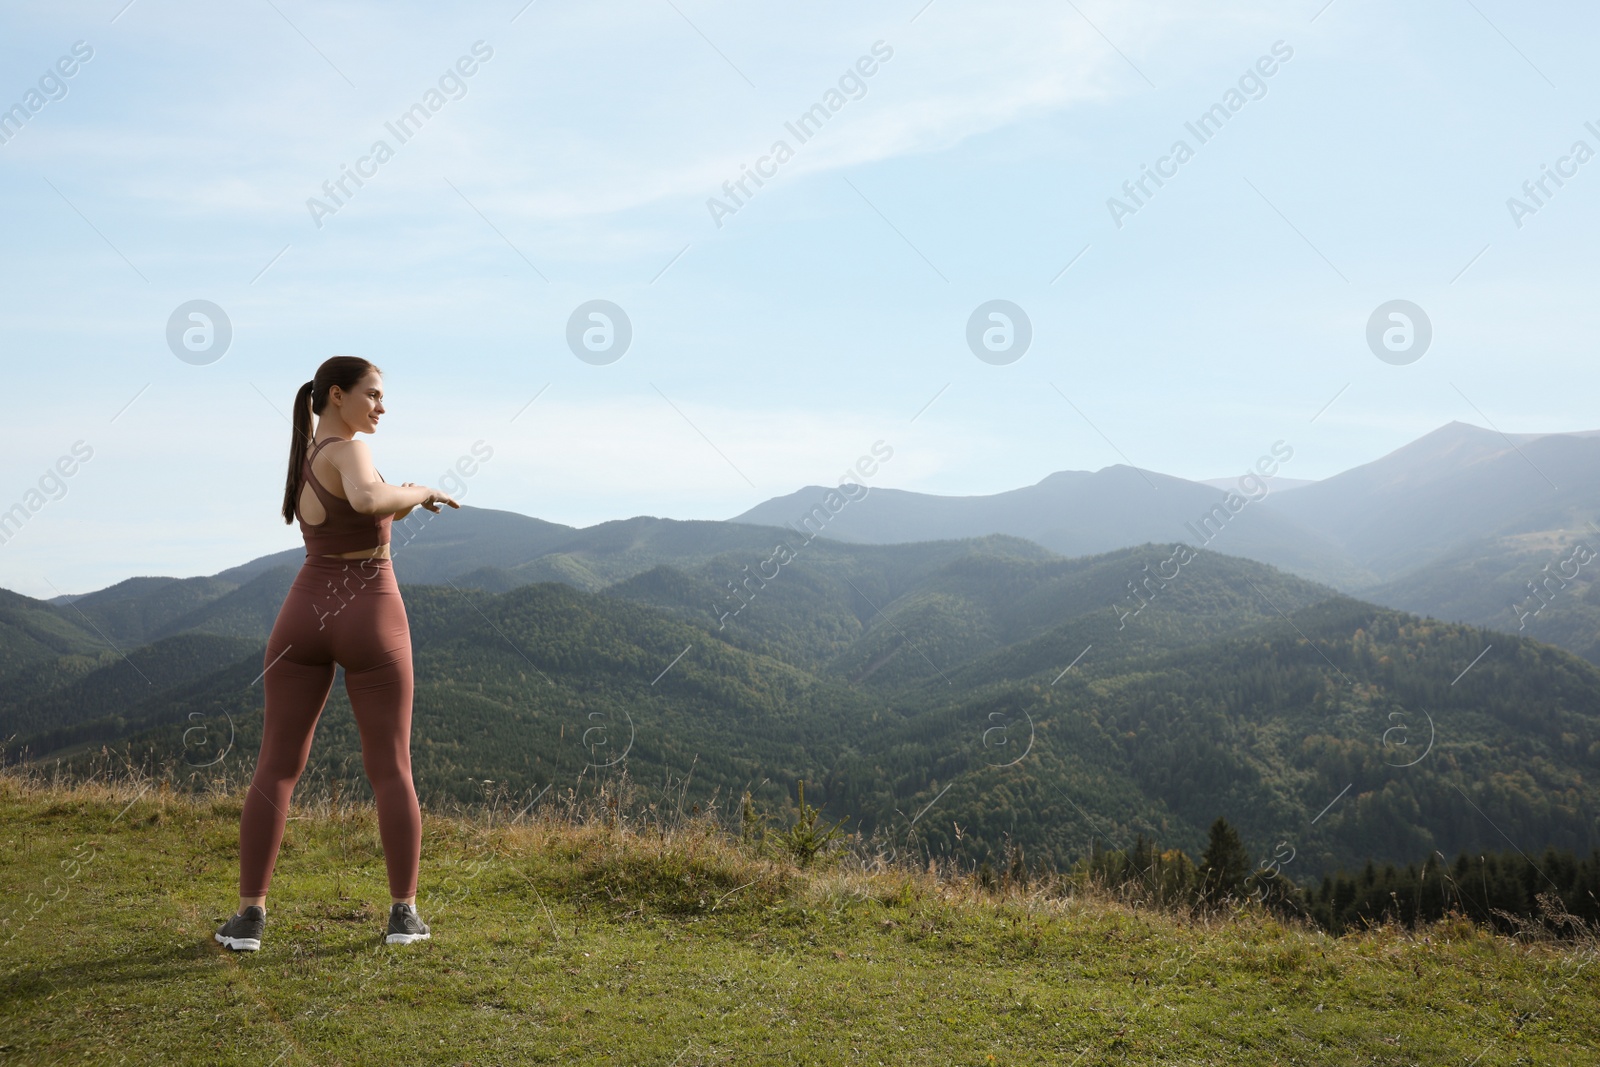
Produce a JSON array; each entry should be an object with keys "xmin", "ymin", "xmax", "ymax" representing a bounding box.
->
[{"xmin": 730, "ymin": 422, "xmax": 1600, "ymax": 662}]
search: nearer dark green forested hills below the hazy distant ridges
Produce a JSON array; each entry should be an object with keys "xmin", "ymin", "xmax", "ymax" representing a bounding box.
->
[{"xmin": 0, "ymin": 537, "xmax": 1600, "ymax": 878}]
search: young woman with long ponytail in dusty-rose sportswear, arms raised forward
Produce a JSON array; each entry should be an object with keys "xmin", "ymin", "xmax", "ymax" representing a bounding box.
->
[{"xmin": 216, "ymin": 355, "xmax": 461, "ymax": 952}]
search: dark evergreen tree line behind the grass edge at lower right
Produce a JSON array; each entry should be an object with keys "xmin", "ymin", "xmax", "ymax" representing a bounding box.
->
[{"xmin": 1056, "ymin": 819, "xmax": 1600, "ymax": 934}]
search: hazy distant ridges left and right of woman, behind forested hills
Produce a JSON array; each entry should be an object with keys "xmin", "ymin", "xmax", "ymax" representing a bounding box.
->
[{"xmin": 31, "ymin": 422, "xmax": 1600, "ymax": 662}]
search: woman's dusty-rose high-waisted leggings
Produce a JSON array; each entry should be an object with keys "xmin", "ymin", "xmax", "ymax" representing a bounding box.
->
[{"xmin": 238, "ymin": 555, "xmax": 422, "ymax": 899}]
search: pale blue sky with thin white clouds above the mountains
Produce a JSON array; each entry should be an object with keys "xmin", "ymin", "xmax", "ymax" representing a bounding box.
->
[{"xmin": 0, "ymin": 0, "xmax": 1600, "ymax": 597}]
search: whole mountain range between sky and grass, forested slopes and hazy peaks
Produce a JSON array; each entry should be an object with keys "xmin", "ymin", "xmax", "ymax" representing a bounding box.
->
[{"xmin": 12, "ymin": 424, "xmax": 1600, "ymax": 877}]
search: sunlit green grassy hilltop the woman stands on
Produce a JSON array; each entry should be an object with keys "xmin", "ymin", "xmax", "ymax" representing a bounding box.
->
[{"xmin": 0, "ymin": 776, "xmax": 1600, "ymax": 1067}]
